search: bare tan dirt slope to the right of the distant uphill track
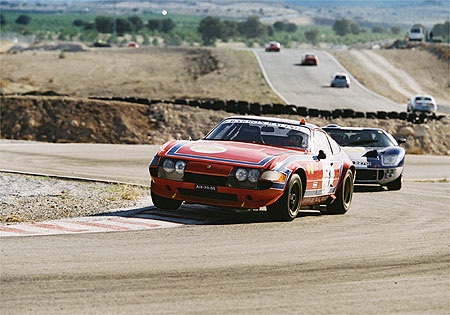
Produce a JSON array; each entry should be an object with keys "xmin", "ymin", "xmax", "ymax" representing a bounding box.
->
[{"xmin": 331, "ymin": 49, "xmax": 450, "ymax": 106}]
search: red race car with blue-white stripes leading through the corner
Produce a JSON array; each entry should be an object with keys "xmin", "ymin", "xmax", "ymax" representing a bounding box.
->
[{"xmin": 149, "ymin": 116, "xmax": 355, "ymax": 221}]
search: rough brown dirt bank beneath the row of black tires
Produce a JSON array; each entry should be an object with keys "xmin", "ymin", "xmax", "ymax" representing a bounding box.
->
[{"xmin": 1, "ymin": 96, "xmax": 450, "ymax": 155}]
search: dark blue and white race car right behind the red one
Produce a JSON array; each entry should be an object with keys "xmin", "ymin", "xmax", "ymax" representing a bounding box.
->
[{"xmin": 323, "ymin": 125, "xmax": 405, "ymax": 190}]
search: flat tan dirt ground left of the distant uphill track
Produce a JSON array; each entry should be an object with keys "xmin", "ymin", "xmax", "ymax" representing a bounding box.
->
[{"xmin": 0, "ymin": 47, "xmax": 280, "ymax": 103}]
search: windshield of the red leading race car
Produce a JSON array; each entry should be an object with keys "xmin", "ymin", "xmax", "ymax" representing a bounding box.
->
[{"xmin": 204, "ymin": 119, "xmax": 310, "ymax": 150}]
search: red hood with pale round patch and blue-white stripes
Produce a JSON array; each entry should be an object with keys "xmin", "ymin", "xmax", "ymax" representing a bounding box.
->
[{"xmin": 158, "ymin": 140, "xmax": 304, "ymax": 167}]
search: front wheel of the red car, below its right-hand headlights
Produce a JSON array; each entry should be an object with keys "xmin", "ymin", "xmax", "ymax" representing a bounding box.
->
[{"xmin": 267, "ymin": 174, "xmax": 303, "ymax": 221}]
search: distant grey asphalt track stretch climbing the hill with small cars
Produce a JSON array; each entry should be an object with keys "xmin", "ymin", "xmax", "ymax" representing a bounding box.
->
[{"xmin": 253, "ymin": 48, "xmax": 406, "ymax": 112}]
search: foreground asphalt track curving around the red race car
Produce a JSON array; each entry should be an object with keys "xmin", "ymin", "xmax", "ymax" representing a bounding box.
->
[{"xmin": 0, "ymin": 142, "xmax": 450, "ymax": 314}]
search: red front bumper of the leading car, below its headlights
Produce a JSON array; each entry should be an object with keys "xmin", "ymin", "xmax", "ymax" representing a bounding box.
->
[{"xmin": 151, "ymin": 177, "xmax": 283, "ymax": 209}]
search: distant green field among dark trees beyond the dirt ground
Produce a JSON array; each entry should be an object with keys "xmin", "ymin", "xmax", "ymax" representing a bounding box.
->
[{"xmin": 1, "ymin": 12, "xmax": 402, "ymax": 47}]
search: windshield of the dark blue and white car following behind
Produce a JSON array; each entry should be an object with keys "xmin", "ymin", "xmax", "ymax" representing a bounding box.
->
[{"xmin": 325, "ymin": 128, "xmax": 396, "ymax": 147}]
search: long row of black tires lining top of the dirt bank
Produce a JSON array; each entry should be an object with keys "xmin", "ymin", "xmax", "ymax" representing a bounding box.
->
[{"xmin": 50, "ymin": 91, "xmax": 448, "ymax": 124}]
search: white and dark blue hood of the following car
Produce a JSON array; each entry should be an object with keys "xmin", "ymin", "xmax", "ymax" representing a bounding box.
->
[{"xmin": 342, "ymin": 147, "xmax": 405, "ymax": 167}]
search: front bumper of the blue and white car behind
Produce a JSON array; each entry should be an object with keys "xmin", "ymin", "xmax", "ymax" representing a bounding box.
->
[{"xmin": 355, "ymin": 166, "xmax": 403, "ymax": 185}]
